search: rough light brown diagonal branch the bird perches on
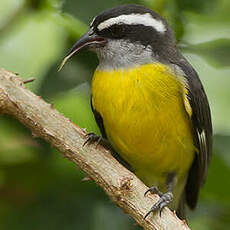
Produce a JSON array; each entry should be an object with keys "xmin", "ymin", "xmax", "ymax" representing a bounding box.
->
[{"xmin": 0, "ymin": 69, "xmax": 189, "ymax": 230}]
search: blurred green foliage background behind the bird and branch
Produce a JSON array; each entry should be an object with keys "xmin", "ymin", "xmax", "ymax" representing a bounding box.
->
[{"xmin": 0, "ymin": 0, "xmax": 230, "ymax": 230}]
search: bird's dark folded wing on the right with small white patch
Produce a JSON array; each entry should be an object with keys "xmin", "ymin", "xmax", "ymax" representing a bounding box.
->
[{"xmin": 174, "ymin": 57, "xmax": 212, "ymax": 209}]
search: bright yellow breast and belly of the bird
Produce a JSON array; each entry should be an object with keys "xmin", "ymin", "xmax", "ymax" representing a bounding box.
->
[{"xmin": 92, "ymin": 64, "xmax": 195, "ymax": 207}]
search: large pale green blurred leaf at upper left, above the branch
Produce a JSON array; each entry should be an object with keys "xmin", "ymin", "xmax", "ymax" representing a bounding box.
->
[{"xmin": 0, "ymin": 11, "xmax": 66, "ymax": 91}]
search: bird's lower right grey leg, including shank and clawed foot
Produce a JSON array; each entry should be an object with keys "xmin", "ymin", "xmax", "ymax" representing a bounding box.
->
[{"xmin": 144, "ymin": 173, "xmax": 176, "ymax": 219}]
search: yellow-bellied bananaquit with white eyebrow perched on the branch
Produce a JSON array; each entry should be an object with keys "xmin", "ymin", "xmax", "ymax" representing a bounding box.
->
[{"xmin": 59, "ymin": 5, "xmax": 212, "ymax": 218}]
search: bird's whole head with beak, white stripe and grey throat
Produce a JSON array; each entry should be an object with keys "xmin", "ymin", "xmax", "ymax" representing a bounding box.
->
[{"xmin": 61, "ymin": 5, "xmax": 176, "ymax": 70}]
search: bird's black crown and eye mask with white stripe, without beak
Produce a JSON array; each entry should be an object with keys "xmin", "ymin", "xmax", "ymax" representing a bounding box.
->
[{"xmin": 90, "ymin": 5, "xmax": 175, "ymax": 50}]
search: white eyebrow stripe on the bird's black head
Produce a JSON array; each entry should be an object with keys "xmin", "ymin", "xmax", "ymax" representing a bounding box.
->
[{"xmin": 97, "ymin": 13, "xmax": 166, "ymax": 33}]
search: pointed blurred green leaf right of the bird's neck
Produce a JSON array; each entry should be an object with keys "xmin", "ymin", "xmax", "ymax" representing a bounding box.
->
[{"xmin": 182, "ymin": 39, "xmax": 230, "ymax": 68}]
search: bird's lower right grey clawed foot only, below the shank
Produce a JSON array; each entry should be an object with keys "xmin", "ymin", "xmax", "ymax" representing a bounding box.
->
[{"xmin": 144, "ymin": 186, "xmax": 173, "ymax": 219}]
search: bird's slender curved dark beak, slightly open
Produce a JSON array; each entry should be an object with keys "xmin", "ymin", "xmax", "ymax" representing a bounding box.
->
[{"xmin": 58, "ymin": 29, "xmax": 107, "ymax": 71}]
